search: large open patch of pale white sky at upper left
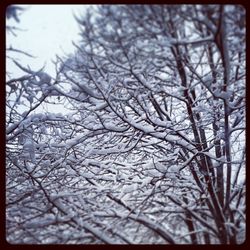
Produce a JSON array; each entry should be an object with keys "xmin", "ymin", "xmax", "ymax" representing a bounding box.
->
[{"xmin": 7, "ymin": 5, "xmax": 88, "ymax": 77}]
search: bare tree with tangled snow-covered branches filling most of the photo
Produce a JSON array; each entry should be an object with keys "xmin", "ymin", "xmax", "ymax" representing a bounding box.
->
[{"xmin": 7, "ymin": 5, "xmax": 245, "ymax": 244}]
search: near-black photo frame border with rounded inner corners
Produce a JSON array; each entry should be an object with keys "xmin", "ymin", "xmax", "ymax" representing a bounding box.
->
[{"xmin": 0, "ymin": 0, "xmax": 250, "ymax": 250}]
